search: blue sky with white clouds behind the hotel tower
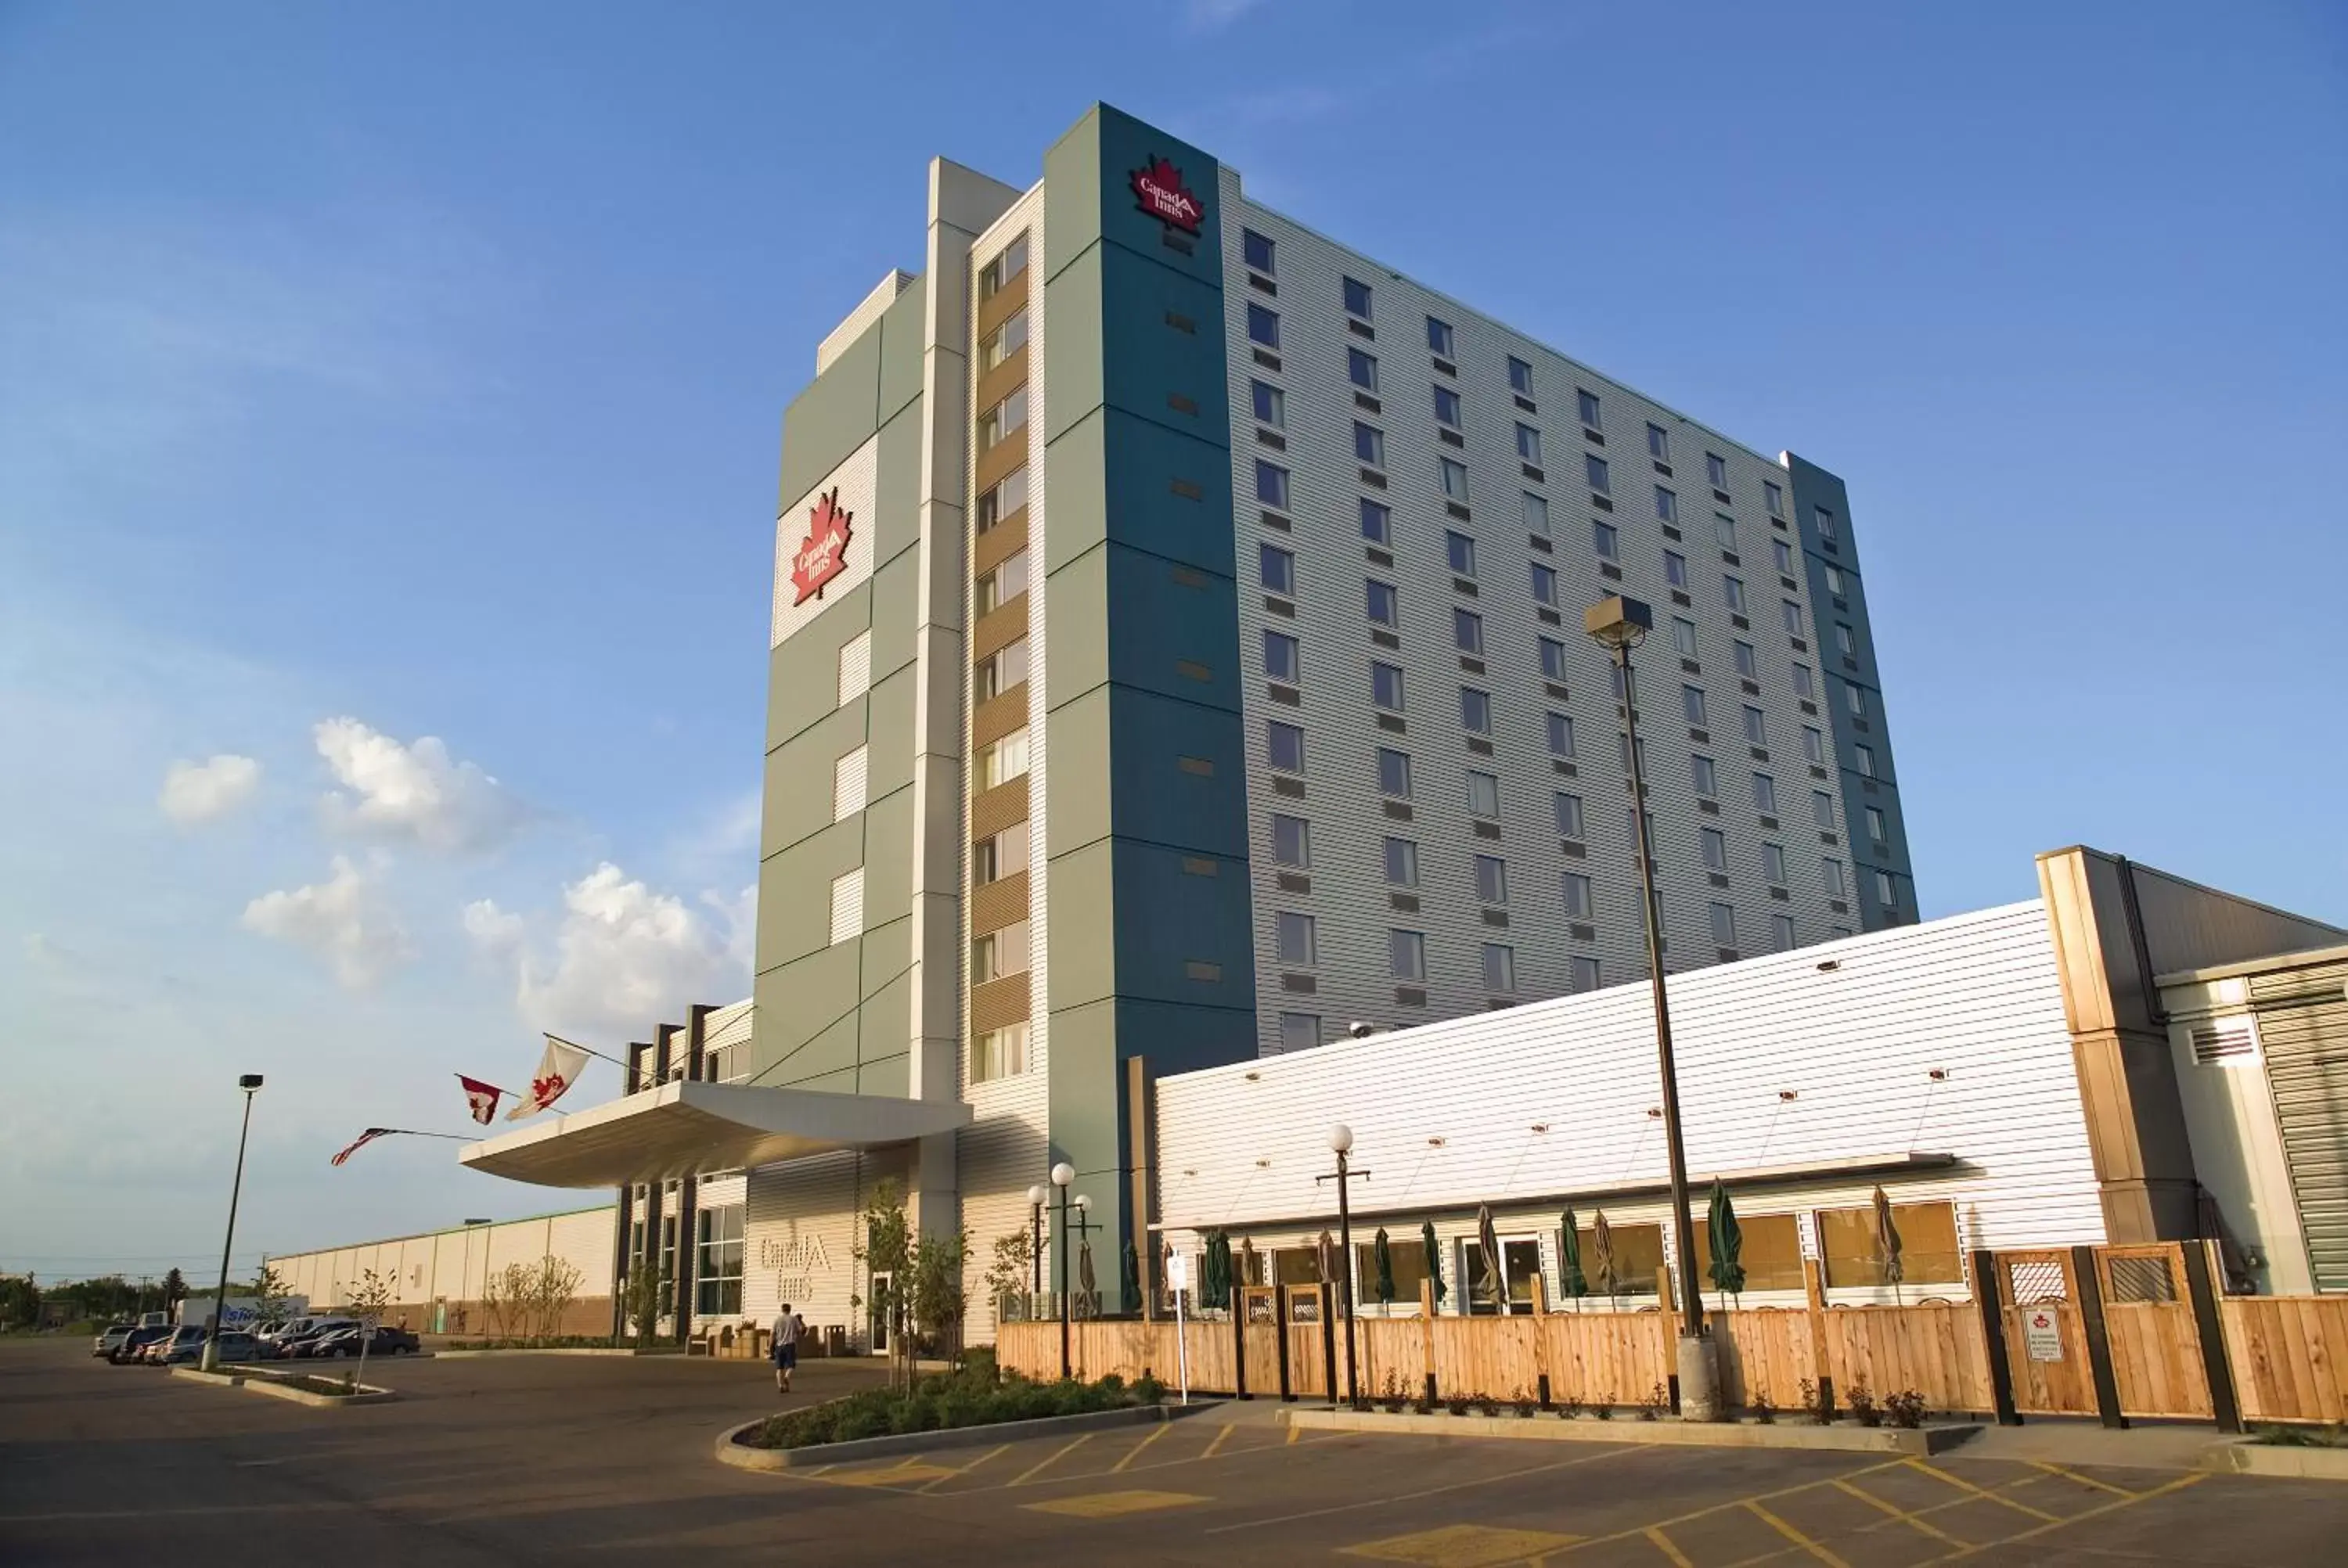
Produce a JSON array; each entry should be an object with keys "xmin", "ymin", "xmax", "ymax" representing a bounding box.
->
[{"xmin": 0, "ymin": 0, "xmax": 2348, "ymax": 1275}]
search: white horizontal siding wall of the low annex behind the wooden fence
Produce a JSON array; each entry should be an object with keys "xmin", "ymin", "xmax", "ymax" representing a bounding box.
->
[{"xmin": 1158, "ymin": 901, "xmax": 2104, "ymax": 1286}]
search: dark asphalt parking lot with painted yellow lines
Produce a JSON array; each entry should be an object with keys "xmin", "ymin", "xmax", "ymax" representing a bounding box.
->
[{"xmin": 0, "ymin": 1343, "xmax": 2348, "ymax": 1568}]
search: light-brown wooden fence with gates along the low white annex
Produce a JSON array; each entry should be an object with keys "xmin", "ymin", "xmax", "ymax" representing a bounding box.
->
[{"xmin": 996, "ymin": 1242, "xmax": 2348, "ymax": 1430}]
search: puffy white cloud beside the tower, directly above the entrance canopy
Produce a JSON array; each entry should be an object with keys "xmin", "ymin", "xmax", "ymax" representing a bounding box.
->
[{"xmin": 477, "ymin": 861, "xmax": 756, "ymax": 1038}]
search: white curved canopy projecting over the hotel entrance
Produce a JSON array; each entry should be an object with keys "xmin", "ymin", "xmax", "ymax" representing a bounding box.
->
[{"xmin": 458, "ymin": 1080, "xmax": 970, "ymax": 1188}]
